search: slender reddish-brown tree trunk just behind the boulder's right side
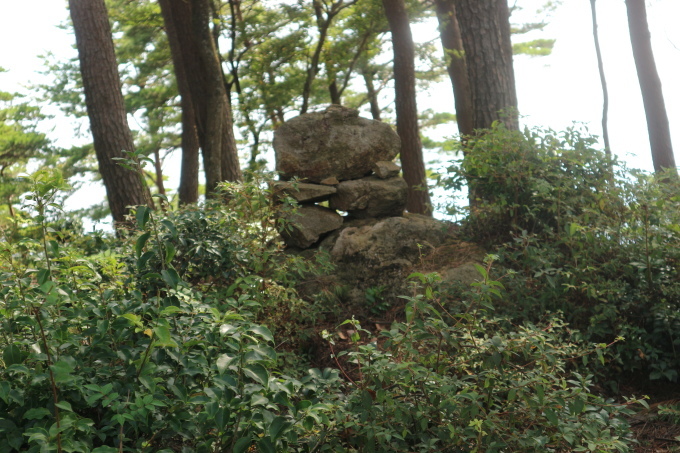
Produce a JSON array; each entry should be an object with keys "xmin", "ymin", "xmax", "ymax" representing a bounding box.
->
[{"xmin": 383, "ymin": 0, "xmax": 432, "ymax": 215}]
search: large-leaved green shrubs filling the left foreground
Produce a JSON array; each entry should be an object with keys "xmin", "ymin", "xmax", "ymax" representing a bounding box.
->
[{"xmin": 0, "ymin": 173, "xmax": 333, "ymax": 452}]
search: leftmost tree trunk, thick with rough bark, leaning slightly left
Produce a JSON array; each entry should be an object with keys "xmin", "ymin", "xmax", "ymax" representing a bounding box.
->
[{"xmin": 69, "ymin": 0, "xmax": 152, "ymax": 226}]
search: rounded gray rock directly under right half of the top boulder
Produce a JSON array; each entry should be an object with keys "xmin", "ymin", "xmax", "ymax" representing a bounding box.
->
[{"xmin": 329, "ymin": 176, "xmax": 408, "ymax": 219}]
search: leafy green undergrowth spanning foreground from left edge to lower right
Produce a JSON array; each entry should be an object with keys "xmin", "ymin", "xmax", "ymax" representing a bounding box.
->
[{"xmin": 0, "ymin": 154, "xmax": 660, "ymax": 453}]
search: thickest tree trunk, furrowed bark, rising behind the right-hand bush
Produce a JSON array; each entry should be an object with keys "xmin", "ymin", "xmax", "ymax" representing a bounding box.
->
[{"xmin": 455, "ymin": 0, "xmax": 519, "ymax": 130}]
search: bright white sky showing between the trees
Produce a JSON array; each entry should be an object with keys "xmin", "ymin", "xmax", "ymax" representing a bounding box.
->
[{"xmin": 0, "ymin": 0, "xmax": 680, "ymax": 224}]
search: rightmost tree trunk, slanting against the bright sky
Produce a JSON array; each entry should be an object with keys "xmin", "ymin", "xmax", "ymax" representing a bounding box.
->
[{"xmin": 626, "ymin": 0, "xmax": 676, "ymax": 173}]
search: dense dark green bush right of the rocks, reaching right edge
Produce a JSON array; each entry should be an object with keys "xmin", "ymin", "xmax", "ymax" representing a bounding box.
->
[{"xmin": 445, "ymin": 126, "xmax": 680, "ymax": 380}]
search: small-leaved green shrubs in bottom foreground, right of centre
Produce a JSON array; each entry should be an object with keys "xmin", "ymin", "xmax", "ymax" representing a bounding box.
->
[{"xmin": 322, "ymin": 267, "xmax": 632, "ymax": 452}]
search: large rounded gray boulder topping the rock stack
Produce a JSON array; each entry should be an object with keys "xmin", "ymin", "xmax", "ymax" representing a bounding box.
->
[{"xmin": 273, "ymin": 105, "xmax": 401, "ymax": 183}]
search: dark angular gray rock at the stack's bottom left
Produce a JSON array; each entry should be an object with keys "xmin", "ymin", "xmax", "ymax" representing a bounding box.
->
[{"xmin": 280, "ymin": 206, "xmax": 343, "ymax": 249}]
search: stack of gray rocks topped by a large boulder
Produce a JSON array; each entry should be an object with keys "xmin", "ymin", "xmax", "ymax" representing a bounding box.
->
[{"xmin": 273, "ymin": 105, "xmax": 407, "ymax": 249}]
